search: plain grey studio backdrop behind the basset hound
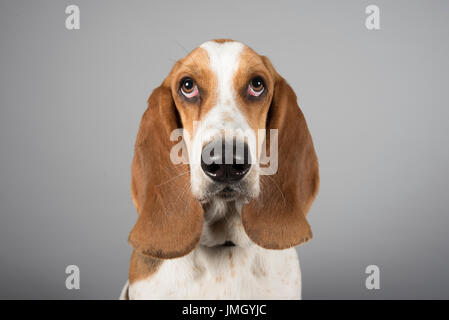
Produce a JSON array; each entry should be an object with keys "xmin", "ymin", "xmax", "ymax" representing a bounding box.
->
[{"xmin": 0, "ymin": 0, "xmax": 449, "ymax": 299}]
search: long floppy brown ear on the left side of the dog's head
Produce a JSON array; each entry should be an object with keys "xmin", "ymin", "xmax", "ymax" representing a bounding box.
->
[{"xmin": 129, "ymin": 81, "xmax": 203, "ymax": 259}]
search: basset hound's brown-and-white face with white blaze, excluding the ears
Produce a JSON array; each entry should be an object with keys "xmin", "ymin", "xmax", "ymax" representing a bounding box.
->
[{"xmin": 168, "ymin": 41, "xmax": 274, "ymax": 203}]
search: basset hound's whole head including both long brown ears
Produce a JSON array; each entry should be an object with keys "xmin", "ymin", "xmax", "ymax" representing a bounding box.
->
[{"xmin": 129, "ymin": 40, "xmax": 319, "ymax": 258}]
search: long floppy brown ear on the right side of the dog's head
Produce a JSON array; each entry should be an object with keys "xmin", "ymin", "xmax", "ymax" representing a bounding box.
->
[{"xmin": 242, "ymin": 57, "xmax": 319, "ymax": 249}]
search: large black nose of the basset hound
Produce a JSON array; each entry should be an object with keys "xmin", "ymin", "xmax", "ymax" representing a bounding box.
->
[{"xmin": 201, "ymin": 140, "xmax": 251, "ymax": 183}]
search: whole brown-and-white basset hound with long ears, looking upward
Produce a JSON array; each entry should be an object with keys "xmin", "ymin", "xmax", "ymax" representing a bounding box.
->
[{"xmin": 121, "ymin": 40, "xmax": 319, "ymax": 299}]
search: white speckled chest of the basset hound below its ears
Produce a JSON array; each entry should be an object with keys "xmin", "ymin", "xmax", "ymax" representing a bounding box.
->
[{"xmin": 129, "ymin": 247, "xmax": 301, "ymax": 299}]
